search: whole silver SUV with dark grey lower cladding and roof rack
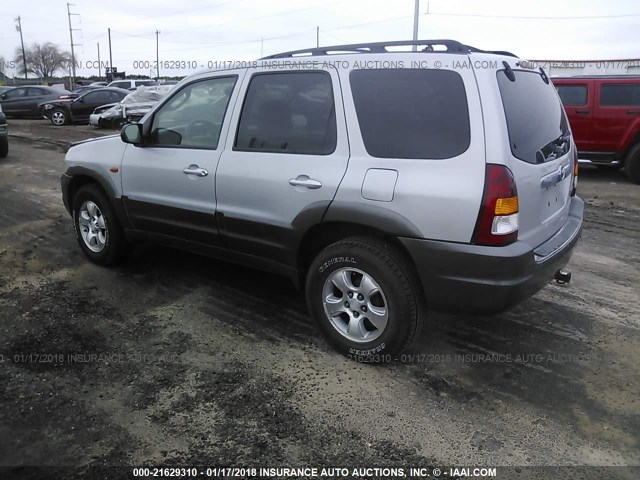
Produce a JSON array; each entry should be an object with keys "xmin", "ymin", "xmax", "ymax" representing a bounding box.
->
[{"xmin": 62, "ymin": 40, "xmax": 584, "ymax": 359}]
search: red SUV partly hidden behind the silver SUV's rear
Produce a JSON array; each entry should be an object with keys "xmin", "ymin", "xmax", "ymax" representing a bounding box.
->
[{"xmin": 552, "ymin": 75, "xmax": 640, "ymax": 184}]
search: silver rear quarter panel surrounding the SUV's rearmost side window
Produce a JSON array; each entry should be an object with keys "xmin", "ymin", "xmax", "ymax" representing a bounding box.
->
[{"xmin": 330, "ymin": 54, "xmax": 485, "ymax": 242}]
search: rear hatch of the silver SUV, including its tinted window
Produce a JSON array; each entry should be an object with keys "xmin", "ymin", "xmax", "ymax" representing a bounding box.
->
[{"xmin": 496, "ymin": 68, "xmax": 575, "ymax": 247}]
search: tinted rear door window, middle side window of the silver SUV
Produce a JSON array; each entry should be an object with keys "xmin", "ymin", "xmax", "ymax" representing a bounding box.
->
[{"xmin": 235, "ymin": 72, "xmax": 336, "ymax": 155}]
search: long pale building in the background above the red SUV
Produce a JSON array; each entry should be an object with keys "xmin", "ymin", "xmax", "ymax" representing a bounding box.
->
[{"xmin": 531, "ymin": 58, "xmax": 640, "ymax": 77}]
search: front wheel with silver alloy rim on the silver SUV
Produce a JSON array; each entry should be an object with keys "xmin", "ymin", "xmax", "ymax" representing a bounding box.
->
[{"xmin": 73, "ymin": 184, "xmax": 127, "ymax": 266}]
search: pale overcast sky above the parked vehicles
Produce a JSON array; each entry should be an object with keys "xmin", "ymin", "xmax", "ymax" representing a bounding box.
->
[{"xmin": 0, "ymin": 0, "xmax": 640, "ymax": 76}]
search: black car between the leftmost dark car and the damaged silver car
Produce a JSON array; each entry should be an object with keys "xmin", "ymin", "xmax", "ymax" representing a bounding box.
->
[{"xmin": 40, "ymin": 87, "xmax": 130, "ymax": 126}]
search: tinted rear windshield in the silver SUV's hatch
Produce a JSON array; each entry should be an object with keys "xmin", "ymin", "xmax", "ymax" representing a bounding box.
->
[{"xmin": 497, "ymin": 70, "xmax": 569, "ymax": 163}]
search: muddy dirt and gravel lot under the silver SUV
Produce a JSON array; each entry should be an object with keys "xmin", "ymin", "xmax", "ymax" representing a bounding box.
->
[{"xmin": 0, "ymin": 121, "xmax": 640, "ymax": 479}]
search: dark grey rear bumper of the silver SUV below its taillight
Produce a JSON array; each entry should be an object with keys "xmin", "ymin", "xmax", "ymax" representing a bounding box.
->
[{"xmin": 400, "ymin": 197, "xmax": 584, "ymax": 314}]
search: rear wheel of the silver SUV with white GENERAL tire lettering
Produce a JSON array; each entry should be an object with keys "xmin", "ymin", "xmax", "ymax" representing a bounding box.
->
[{"xmin": 306, "ymin": 237, "xmax": 423, "ymax": 363}]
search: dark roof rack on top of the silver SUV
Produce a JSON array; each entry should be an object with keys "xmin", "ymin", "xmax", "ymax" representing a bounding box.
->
[{"xmin": 260, "ymin": 39, "xmax": 516, "ymax": 60}]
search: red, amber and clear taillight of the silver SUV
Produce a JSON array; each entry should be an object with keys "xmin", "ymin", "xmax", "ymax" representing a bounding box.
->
[{"xmin": 473, "ymin": 164, "xmax": 519, "ymax": 246}]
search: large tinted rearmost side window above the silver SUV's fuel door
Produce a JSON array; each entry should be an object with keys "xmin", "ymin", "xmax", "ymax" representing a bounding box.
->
[{"xmin": 350, "ymin": 69, "xmax": 471, "ymax": 159}]
